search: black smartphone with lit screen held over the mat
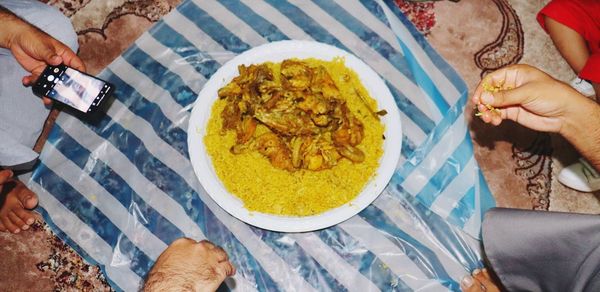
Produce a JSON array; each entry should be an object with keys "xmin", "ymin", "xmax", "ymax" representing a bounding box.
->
[{"xmin": 33, "ymin": 64, "xmax": 115, "ymax": 113}]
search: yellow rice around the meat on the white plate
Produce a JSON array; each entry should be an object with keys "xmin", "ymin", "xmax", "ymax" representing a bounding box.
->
[{"xmin": 204, "ymin": 58, "xmax": 384, "ymax": 216}]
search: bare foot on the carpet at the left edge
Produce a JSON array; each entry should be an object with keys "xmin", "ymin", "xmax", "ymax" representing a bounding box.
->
[{"xmin": 0, "ymin": 169, "xmax": 38, "ymax": 233}]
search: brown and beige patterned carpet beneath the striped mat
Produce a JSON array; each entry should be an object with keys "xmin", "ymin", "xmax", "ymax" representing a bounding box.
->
[{"xmin": 0, "ymin": 0, "xmax": 600, "ymax": 291}]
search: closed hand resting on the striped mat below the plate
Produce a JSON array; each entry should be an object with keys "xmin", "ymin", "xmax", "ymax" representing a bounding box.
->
[{"xmin": 144, "ymin": 238, "xmax": 235, "ymax": 292}]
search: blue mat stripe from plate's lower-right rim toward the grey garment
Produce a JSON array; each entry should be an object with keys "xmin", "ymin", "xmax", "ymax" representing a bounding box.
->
[{"xmin": 390, "ymin": 185, "xmax": 481, "ymax": 271}]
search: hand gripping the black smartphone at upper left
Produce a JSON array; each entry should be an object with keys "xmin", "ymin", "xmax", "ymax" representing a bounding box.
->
[{"xmin": 5, "ymin": 20, "xmax": 86, "ymax": 104}]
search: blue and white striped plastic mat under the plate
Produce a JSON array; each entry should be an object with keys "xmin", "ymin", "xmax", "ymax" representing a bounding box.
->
[{"xmin": 29, "ymin": 0, "xmax": 494, "ymax": 291}]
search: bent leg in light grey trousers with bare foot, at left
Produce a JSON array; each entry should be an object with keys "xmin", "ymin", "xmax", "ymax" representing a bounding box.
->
[{"xmin": 0, "ymin": 0, "xmax": 78, "ymax": 233}]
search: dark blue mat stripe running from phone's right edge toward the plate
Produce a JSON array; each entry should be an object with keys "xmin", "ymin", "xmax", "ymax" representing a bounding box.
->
[{"xmin": 102, "ymin": 69, "xmax": 188, "ymax": 157}]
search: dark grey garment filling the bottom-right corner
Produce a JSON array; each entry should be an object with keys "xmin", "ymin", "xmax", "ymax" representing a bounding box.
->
[{"xmin": 482, "ymin": 208, "xmax": 600, "ymax": 292}]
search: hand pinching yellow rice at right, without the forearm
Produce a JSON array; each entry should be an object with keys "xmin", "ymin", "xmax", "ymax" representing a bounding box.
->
[{"xmin": 471, "ymin": 65, "xmax": 589, "ymax": 132}]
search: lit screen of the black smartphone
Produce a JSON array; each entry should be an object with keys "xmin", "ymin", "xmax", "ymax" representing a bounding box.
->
[{"xmin": 48, "ymin": 68, "xmax": 106, "ymax": 112}]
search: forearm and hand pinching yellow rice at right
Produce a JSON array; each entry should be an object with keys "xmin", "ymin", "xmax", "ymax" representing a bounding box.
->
[{"xmin": 471, "ymin": 65, "xmax": 600, "ymax": 170}]
